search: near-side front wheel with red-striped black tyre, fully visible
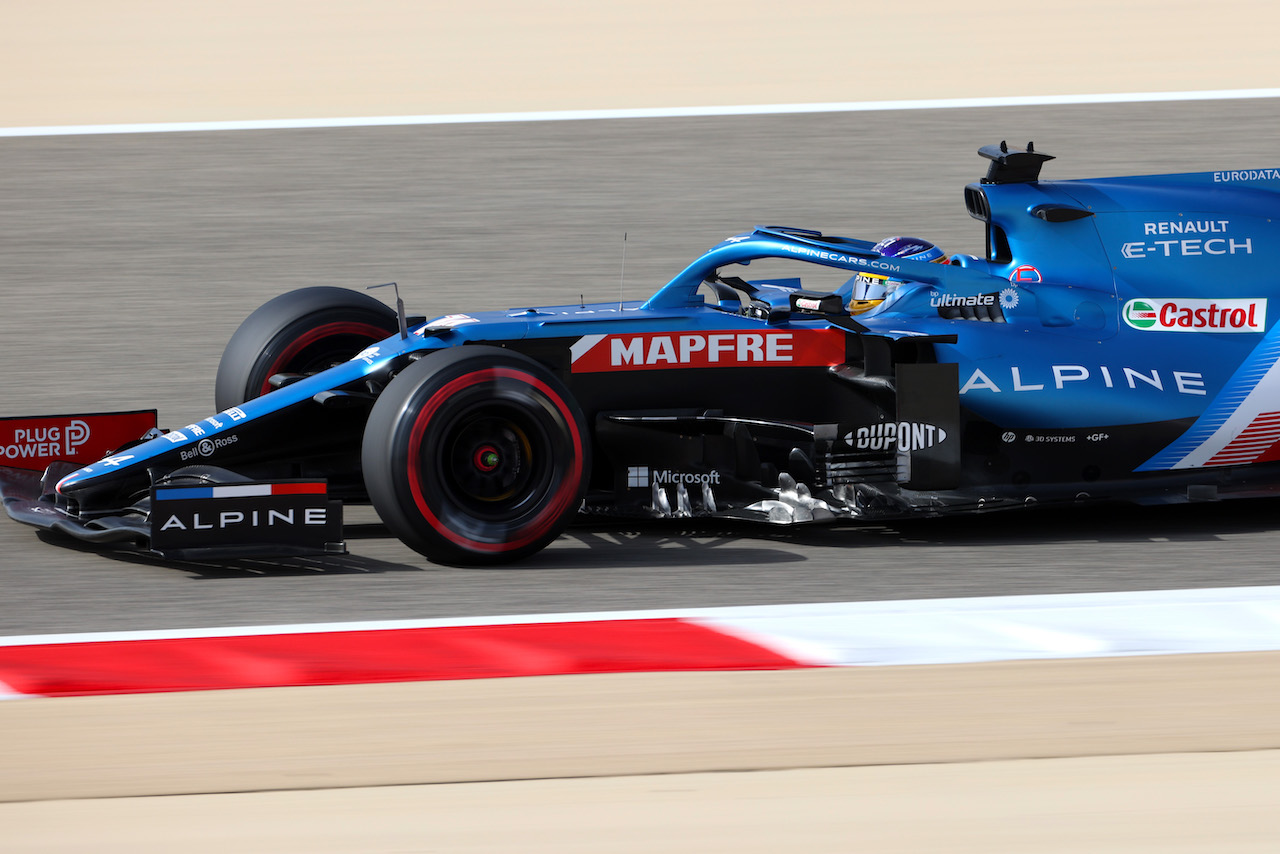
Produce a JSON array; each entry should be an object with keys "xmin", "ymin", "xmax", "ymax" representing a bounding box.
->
[{"xmin": 361, "ymin": 346, "xmax": 590, "ymax": 566}]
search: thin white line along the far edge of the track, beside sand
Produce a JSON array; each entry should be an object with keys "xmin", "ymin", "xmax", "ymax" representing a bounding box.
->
[{"xmin": 0, "ymin": 88, "xmax": 1280, "ymax": 137}]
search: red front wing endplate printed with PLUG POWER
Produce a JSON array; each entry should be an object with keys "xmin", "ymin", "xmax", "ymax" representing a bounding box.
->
[{"xmin": 0, "ymin": 410, "xmax": 156, "ymax": 471}]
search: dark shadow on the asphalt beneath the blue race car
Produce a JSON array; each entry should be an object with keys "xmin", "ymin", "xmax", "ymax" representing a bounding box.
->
[{"xmin": 27, "ymin": 498, "xmax": 1280, "ymax": 579}]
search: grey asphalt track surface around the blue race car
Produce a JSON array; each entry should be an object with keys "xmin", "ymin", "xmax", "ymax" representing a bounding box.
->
[{"xmin": 0, "ymin": 100, "xmax": 1280, "ymax": 635}]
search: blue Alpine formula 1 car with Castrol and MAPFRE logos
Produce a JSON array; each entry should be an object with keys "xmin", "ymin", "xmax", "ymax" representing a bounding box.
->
[{"xmin": 0, "ymin": 143, "xmax": 1280, "ymax": 565}]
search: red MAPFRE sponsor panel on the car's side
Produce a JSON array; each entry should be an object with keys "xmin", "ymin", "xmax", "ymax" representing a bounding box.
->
[{"xmin": 573, "ymin": 329, "xmax": 845, "ymax": 374}]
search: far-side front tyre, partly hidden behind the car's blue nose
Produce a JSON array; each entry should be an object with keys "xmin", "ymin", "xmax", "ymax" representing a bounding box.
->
[{"xmin": 214, "ymin": 288, "xmax": 399, "ymax": 411}]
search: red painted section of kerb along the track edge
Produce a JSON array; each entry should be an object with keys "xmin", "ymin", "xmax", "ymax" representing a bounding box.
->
[{"xmin": 0, "ymin": 618, "xmax": 809, "ymax": 697}]
